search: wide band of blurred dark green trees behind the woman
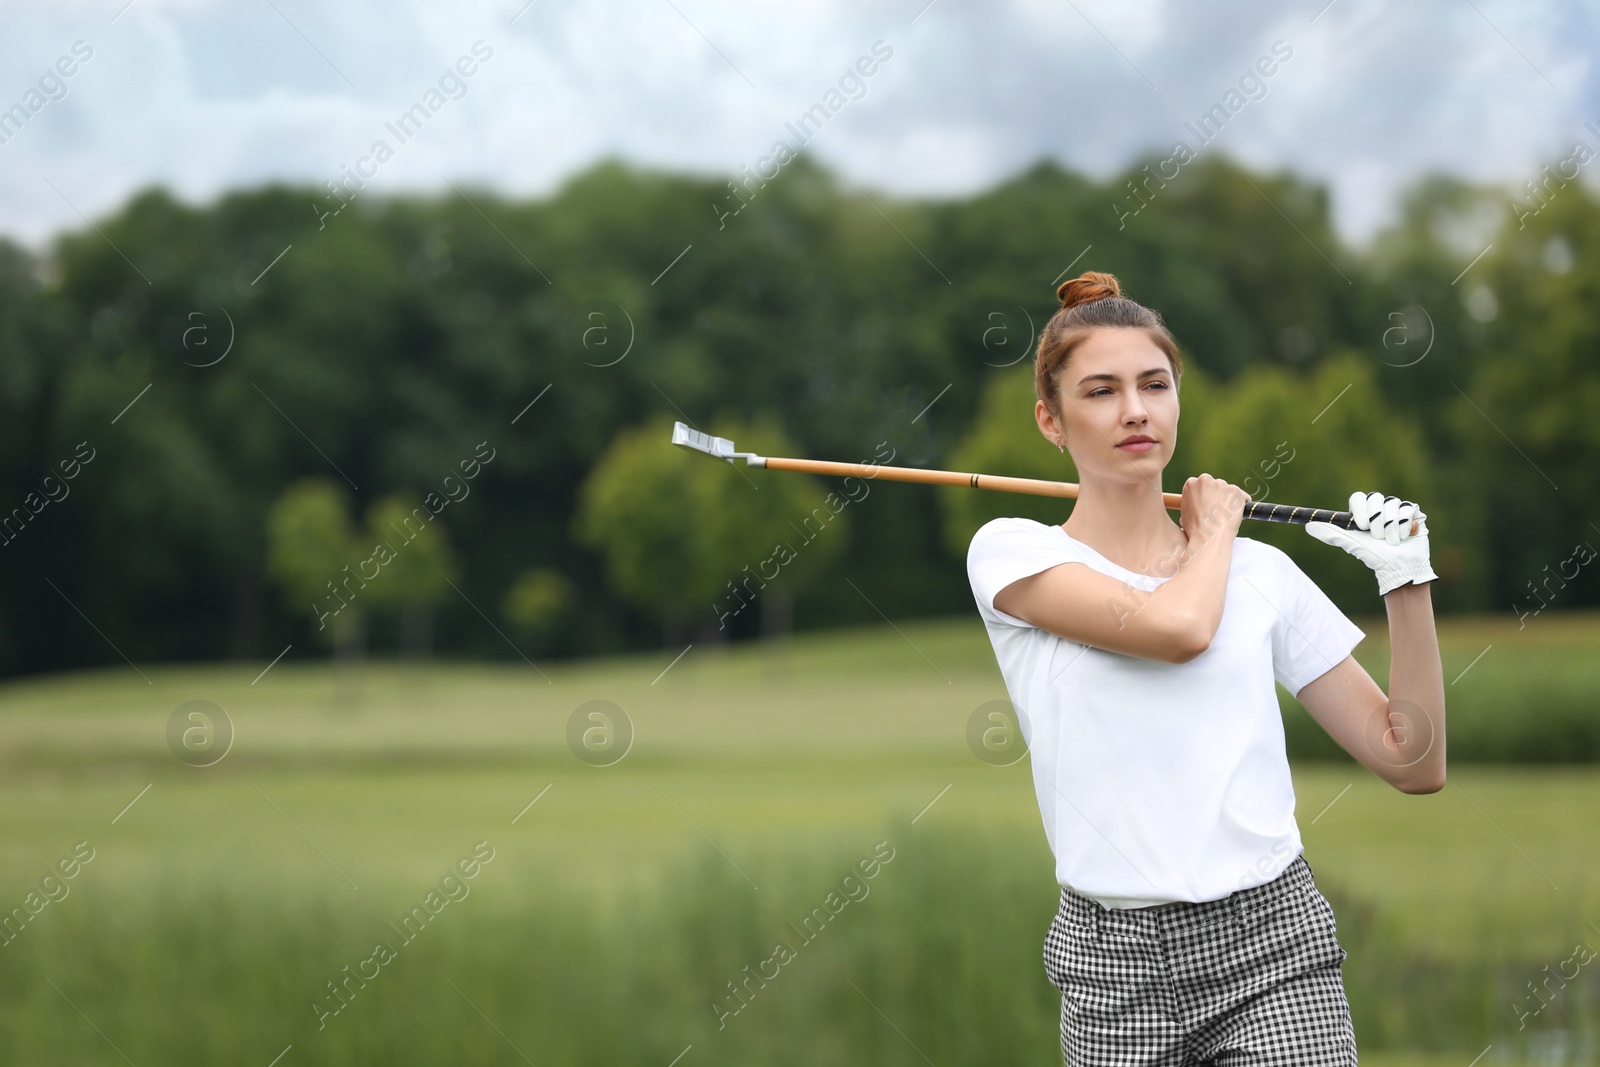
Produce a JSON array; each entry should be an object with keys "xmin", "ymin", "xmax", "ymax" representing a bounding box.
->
[{"xmin": 0, "ymin": 155, "xmax": 1600, "ymax": 673}]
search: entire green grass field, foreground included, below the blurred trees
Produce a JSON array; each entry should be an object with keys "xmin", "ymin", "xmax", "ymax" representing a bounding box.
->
[{"xmin": 0, "ymin": 616, "xmax": 1600, "ymax": 1067}]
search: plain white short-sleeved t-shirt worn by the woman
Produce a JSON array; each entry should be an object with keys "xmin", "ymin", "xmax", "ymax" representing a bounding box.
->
[{"xmin": 966, "ymin": 518, "xmax": 1365, "ymax": 909}]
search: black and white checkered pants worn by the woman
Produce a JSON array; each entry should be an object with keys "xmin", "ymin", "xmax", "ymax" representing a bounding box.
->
[{"xmin": 1045, "ymin": 856, "xmax": 1355, "ymax": 1067}]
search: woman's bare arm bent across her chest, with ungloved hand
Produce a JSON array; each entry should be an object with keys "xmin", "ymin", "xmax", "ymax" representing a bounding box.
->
[{"xmin": 995, "ymin": 475, "xmax": 1250, "ymax": 664}]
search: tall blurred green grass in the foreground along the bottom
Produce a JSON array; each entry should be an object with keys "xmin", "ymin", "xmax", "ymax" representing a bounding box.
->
[{"xmin": 0, "ymin": 825, "xmax": 1600, "ymax": 1067}]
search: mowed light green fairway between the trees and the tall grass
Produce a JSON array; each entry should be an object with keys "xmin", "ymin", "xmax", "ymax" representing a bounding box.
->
[{"xmin": 0, "ymin": 617, "xmax": 1600, "ymax": 1064}]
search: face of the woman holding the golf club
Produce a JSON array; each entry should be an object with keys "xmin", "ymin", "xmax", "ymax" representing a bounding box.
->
[{"xmin": 1034, "ymin": 328, "xmax": 1178, "ymax": 485}]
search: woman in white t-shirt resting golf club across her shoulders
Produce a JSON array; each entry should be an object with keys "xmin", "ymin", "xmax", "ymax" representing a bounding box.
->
[{"xmin": 966, "ymin": 272, "xmax": 1445, "ymax": 1067}]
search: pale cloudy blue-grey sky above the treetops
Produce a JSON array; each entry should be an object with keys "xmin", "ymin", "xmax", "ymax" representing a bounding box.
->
[{"xmin": 0, "ymin": 0, "xmax": 1600, "ymax": 248}]
